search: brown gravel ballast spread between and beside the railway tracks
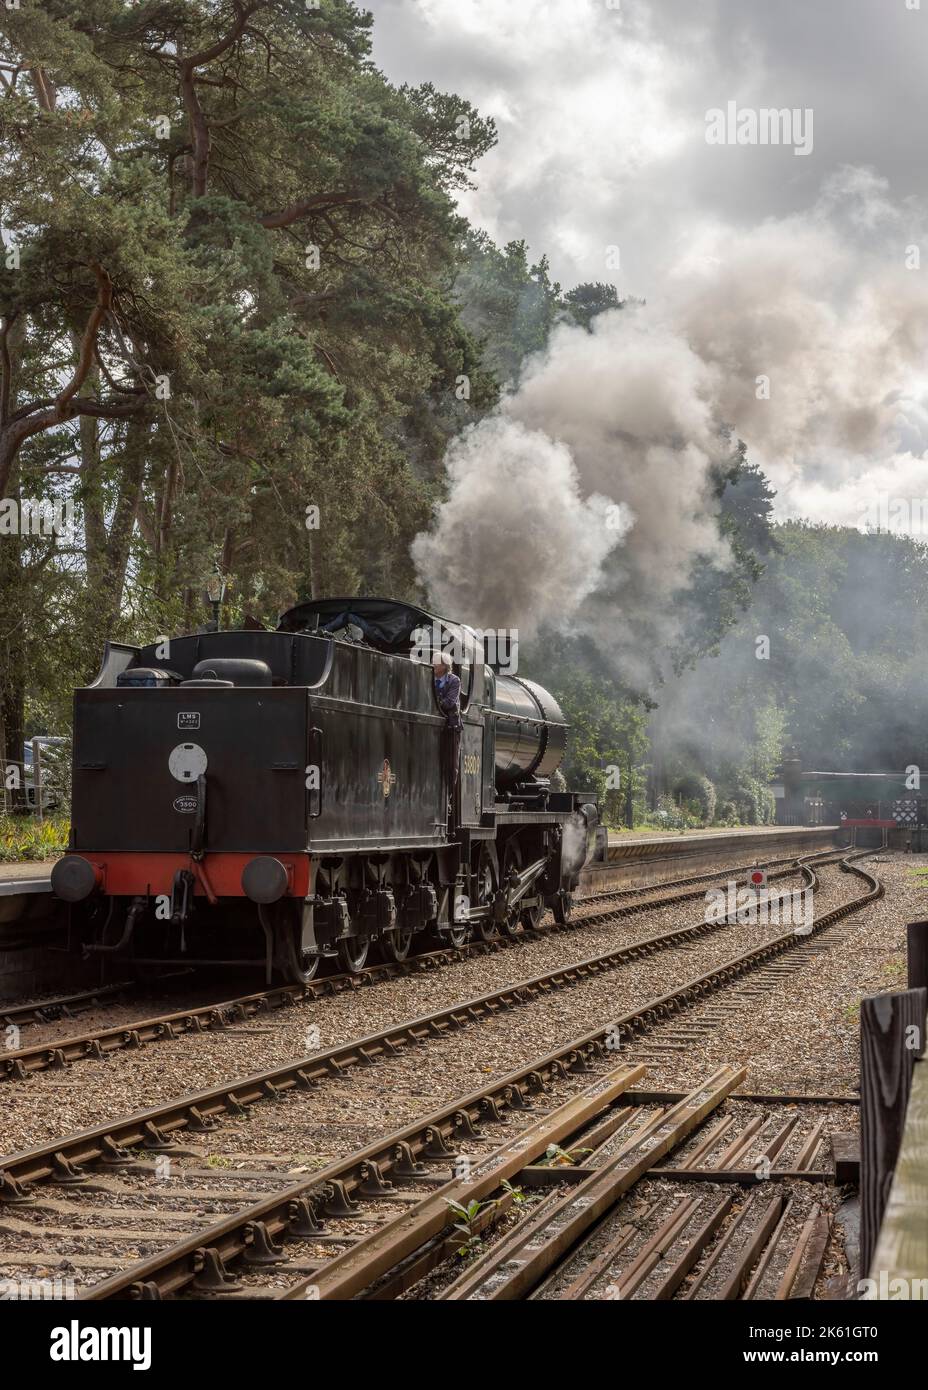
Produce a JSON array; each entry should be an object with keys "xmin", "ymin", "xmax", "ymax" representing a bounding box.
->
[{"xmin": 0, "ymin": 855, "xmax": 905, "ymax": 1297}]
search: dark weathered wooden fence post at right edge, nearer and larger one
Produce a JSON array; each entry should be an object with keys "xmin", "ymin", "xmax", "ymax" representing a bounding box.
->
[{"xmin": 860, "ymin": 988, "xmax": 928, "ymax": 1276}]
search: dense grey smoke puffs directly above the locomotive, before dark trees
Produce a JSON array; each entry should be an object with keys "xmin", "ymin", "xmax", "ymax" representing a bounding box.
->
[{"xmin": 413, "ymin": 309, "xmax": 729, "ymax": 649}]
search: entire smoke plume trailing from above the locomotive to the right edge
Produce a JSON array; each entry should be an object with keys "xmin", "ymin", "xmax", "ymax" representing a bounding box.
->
[{"xmin": 413, "ymin": 170, "xmax": 928, "ymax": 678}]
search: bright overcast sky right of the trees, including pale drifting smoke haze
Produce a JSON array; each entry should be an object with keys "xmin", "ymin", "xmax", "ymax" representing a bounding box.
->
[{"xmin": 368, "ymin": 0, "xmax": 928, "ymax": 530}]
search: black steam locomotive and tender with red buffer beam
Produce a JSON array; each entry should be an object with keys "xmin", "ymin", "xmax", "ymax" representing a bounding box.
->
[{"xmin": 51, "ymin": 598, "xmax": 599, "ymax": 983}]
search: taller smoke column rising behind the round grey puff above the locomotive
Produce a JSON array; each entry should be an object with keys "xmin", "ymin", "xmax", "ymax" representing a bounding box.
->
[{"xmin": 503, "ymin": 307, "xmax": 731, "ymax": 628}]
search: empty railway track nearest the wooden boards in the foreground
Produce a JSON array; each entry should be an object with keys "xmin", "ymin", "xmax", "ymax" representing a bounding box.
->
[{"xmin": 0, "ymin": 862, "xmax": 882, "ymax": 1298}]
